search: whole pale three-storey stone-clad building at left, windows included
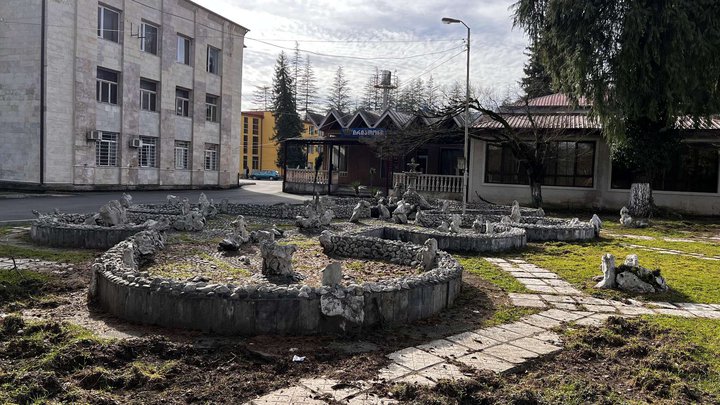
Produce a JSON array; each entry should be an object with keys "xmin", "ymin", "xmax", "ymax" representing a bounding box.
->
[{"xmin": 0, "ymin": 0, "xmax": 248, "ymax": 189}]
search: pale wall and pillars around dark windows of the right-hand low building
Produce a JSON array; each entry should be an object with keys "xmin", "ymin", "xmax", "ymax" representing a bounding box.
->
[{"xmin": 469, "ymin": 138, "xmax": 720, "ymax": 215}]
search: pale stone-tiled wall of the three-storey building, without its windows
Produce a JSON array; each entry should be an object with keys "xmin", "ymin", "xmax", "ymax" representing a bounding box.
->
[{"xmin": 0, "ymin": 0, "xmax": 246, "ymax": 189}]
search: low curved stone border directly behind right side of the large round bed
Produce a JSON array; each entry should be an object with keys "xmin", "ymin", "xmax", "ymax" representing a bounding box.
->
[{"xmin": 357, "ymin": 224, "xmax": 527, "ymax": 253}]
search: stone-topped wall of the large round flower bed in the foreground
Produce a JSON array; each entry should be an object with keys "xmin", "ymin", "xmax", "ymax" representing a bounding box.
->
[{"xmin": 89, "ymin": 231, "xmax": 463, "ymax": 335}]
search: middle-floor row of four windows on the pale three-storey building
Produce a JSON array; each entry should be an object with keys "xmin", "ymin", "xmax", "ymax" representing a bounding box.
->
[{"xmin": 96, "ymin": 68, "xmax": 220, "ymax": 122}]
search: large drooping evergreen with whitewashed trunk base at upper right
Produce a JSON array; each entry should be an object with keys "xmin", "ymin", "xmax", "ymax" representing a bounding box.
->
[{"xmin": 513, "ymin": 0, "xmax": 720, "ymax": 217}]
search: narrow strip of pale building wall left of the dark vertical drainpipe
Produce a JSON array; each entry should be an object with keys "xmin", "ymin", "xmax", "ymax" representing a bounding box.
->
[{"xmin": 0, "ymin": 0, "xmax": 42, "ymax": 183}]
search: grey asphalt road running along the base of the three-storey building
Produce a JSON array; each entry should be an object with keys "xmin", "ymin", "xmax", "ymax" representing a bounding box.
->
[{"xmin": 0, "ymin": 180, "xmax": 308, "ymax": 223}]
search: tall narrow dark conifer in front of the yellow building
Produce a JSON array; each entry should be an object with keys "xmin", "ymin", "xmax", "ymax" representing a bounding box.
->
[{"xmin": 272, "ymin": 52, "xmax": 305, "ymax": 168}]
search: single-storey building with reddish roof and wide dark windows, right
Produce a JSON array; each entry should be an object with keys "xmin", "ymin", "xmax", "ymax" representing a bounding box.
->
[{"xmin": 469, "ymin": 94, "xmax": 720, "ymax": 215}]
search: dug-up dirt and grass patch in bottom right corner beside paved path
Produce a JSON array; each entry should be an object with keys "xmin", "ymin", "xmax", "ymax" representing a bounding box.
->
[{"xmin": 376, "ymin": 318, "xmax": 720, "ymax": 404}]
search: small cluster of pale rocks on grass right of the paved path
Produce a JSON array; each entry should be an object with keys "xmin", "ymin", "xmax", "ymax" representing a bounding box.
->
[{"xmin": 595, "ymin": 254, "xmax": 668, "ymax": 294}]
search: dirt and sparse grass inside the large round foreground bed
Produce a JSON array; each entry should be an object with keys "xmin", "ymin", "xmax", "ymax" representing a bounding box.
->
[{"xmin": 143, "ymin": 233, "xmax": 422, "ymax": 287}]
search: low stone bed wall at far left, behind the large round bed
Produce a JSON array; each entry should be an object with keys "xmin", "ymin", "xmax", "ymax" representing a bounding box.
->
[{"xmin": 30, "ymin": 223, "xmax": 145, "ymax": 249}]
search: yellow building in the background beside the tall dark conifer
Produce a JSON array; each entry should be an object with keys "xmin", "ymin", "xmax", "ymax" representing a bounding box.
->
[{"xmin": 240, "ymin": 111, "xmax": 318, "ymax": 175}]
